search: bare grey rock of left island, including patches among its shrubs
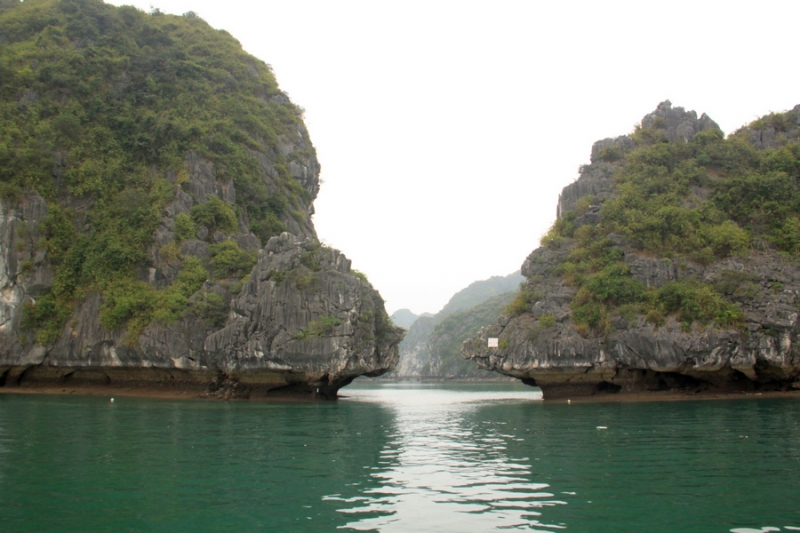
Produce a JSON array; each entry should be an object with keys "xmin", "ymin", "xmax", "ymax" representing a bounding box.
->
[{"xmin": 0, "ymin": 154, "xmax": 402, "ymax": 398}]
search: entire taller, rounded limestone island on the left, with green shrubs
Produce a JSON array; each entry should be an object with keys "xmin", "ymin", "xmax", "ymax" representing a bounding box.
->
[{"xmin": 0, "ymin": 0, "xmax": 401, "ymax": 397}]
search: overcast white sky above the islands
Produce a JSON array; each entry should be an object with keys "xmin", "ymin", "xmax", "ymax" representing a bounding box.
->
[{"xmin": 110, "ymin": 0, "xmax": 800, "ymax": 313}]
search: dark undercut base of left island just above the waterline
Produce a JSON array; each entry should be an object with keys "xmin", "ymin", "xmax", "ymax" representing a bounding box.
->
[{"xmin": 0, "ymin": 366, "xmax": 360, "ymax": 401}]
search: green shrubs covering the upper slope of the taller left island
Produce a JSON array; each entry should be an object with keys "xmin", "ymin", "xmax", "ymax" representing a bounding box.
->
[{"xmin": 0, "ymin": 0, "xmax": 313, "ymax": 344}]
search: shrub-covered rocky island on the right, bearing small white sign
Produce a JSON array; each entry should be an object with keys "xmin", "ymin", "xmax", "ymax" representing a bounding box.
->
[{"xmin": 462, "ymin": 102, "xmax": 800, "ymax": 399}]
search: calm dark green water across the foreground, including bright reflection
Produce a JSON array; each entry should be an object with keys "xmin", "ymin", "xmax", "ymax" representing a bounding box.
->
[{"xmin": 0, "ymin": 383, "xmax": 800, "ymax": 533}]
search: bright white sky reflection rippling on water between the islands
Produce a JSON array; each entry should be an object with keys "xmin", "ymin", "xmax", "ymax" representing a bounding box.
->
[{"xmin": 324, "ymin": 385, "xmax": 566, "ymax": 533}]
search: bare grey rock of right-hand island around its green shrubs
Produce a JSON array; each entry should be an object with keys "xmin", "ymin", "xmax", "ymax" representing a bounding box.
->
[{"xmin": 462, "ymin": 102, "xmax": 800, "ymax": 398}]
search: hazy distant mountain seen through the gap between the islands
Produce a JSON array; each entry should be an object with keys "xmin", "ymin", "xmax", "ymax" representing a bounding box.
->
[{"xmin": 391, "ymin": 272, "xmax": 524, "ymax": 379}]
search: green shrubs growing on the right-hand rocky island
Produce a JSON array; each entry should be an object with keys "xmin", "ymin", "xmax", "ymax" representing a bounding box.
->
[{"xmin": 536, "ymin": 106, "xmax": 800, "ymax": 333}]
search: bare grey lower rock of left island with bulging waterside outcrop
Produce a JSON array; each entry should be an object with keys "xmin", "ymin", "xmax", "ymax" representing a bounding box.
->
[{"xmin": 0, "ymin": 221, "xmax": 403, "ymax": 398}]
